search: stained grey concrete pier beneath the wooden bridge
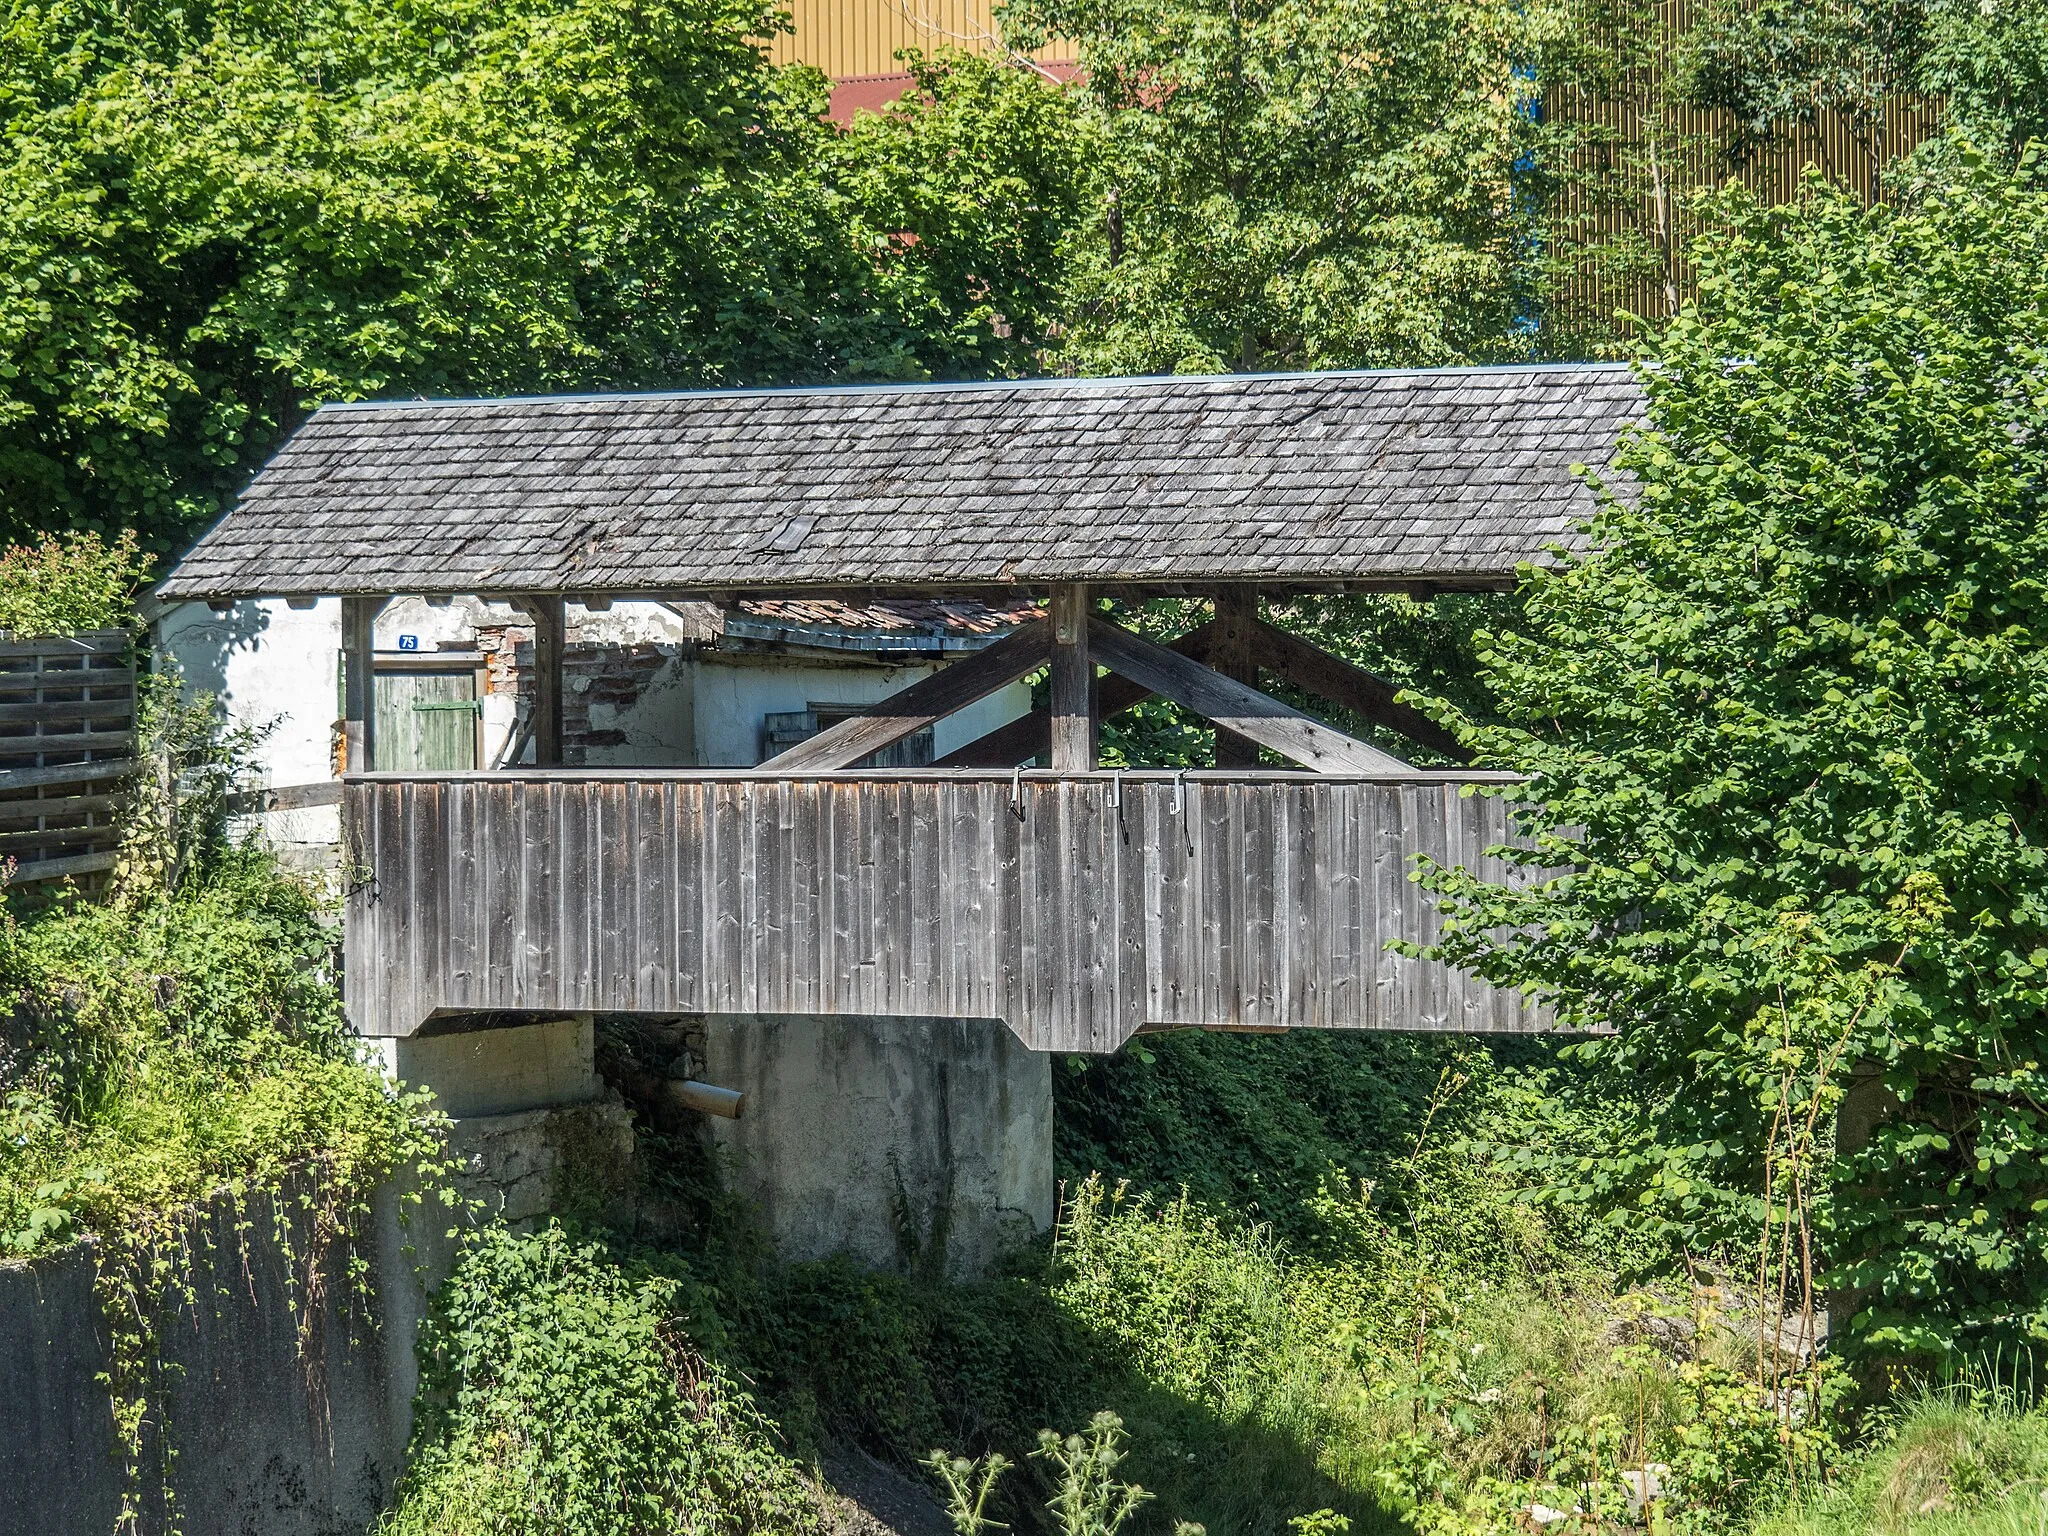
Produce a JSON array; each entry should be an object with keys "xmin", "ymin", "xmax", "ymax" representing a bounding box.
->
[{"xmin": 702, "ymin": 1014, "xmax": 1055, "ymax": 1276}]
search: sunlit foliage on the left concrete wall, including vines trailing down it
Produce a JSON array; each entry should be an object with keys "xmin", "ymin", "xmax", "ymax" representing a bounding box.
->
[{"xmin": 0, "ymin": 850, "xmax": 440, "ymax": 1518}]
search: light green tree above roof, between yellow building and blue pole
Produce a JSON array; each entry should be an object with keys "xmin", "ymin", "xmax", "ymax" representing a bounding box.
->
[{"xmin": 1006, "ymin": 0, "xmax": 1528, "ymax": 373}]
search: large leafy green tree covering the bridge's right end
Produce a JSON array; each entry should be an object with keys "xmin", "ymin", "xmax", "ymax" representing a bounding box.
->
[{"xmin": 1436, "ymin": 156, "xmax": 2048, "ymax": 1356}]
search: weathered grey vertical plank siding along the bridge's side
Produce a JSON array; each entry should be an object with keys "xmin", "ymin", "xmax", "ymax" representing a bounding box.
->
[{"xmin": 344, "ymin": 770, "xmax": 1548, "ymax": 1053}]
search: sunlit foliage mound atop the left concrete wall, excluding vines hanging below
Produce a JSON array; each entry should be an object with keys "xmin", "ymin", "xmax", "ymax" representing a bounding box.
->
[{"xmin": 0, "ymin": 852, "xmax": 432, "ymax": 1255}]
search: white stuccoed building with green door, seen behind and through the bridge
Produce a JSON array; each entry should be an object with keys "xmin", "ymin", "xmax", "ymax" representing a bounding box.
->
[{"xmin": 152, "ymin": 596, "xmax": 1036, "ymax": 864}]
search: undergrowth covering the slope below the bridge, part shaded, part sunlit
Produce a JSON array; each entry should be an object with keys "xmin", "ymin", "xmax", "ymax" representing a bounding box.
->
[{"xmin": 385, "ymin": 1036, "xmax": 1835, "ymax": 1536}]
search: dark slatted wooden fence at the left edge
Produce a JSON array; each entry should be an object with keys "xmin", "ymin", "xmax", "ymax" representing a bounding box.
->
[{"xmin": 0, "ymin": 631, "xmax": 135, "ymax": 885}]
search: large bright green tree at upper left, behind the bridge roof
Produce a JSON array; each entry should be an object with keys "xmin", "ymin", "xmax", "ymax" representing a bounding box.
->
[{"xmin": 0, "ymin": 0, "xmax": 1073, "ymax": 549}]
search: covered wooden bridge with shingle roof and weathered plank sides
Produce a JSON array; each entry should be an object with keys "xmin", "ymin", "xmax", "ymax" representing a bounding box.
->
[{"xmin": 151, "ymin": 365, "xmax": 1640, "ymax": 1051}]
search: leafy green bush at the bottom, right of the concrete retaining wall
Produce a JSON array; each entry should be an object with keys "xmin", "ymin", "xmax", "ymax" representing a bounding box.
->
[{"xmin": 377, "ymin": 1223, "xmax": 819, "ymax": 1536}]
